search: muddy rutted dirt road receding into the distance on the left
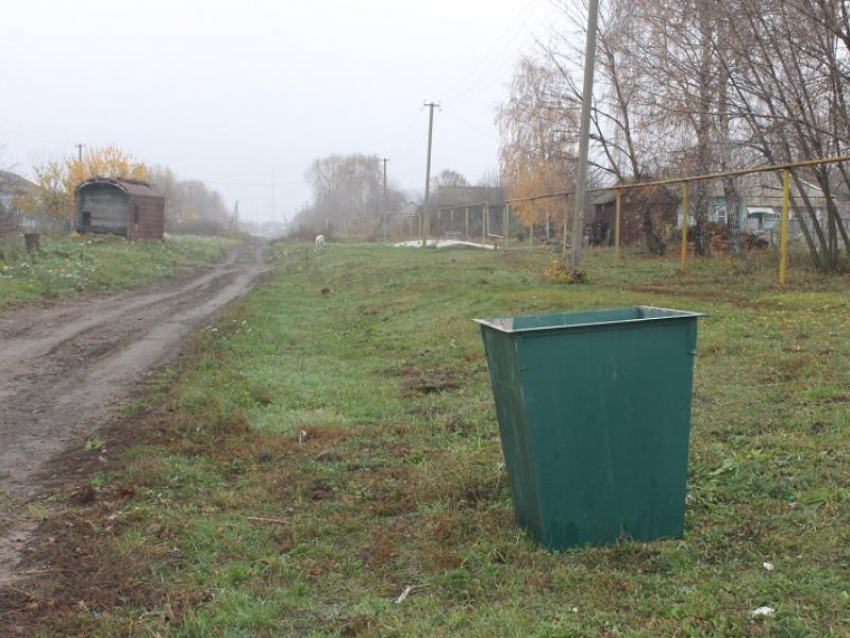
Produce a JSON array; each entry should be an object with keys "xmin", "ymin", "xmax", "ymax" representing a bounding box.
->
[{"xmin": 0, "ymin": 243, "xmax": 267, "ymax": 584}]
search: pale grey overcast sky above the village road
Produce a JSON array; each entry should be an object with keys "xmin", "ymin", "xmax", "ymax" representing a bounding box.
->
[{"xmin": 0, "ymin": 0, "xmax": 557, "ymax": 225}]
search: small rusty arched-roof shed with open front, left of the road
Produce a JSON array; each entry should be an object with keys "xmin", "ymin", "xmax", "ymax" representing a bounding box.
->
[{"xmin": 76, "ymin": 177, "xmax": 165, "ymax": 239}]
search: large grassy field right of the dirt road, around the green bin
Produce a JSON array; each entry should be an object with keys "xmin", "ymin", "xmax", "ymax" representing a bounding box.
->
[{"xmin": 14, "ymin": 244, "xmax": 850, "ymax": 638}]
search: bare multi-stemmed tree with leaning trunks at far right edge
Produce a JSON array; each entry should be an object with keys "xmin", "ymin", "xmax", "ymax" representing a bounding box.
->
[{"xmin": 723, "ymin": 0, "xmax": 850, "ymax": 270}]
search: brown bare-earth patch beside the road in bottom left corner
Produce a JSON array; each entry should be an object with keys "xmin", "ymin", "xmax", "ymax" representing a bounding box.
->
[{"xmin": 0, "ymin": 404, "xmax": 172, "ymax": 636}]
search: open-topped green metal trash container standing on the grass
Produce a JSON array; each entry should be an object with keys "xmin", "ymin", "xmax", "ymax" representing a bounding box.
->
[{"xmin": 477, "ymin": 306, "xmax": 701, "ymax": 549}]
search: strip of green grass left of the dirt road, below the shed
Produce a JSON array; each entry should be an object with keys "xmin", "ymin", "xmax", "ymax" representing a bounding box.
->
[{"xmin": 0, "ymin": 235, "xmax": 236, "ymax": 308}]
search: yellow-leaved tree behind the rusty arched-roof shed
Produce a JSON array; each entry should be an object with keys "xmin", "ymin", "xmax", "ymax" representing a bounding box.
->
[{"xmin": 20, "ymin": 146, "xmax": 148, "ymax": 228}]
